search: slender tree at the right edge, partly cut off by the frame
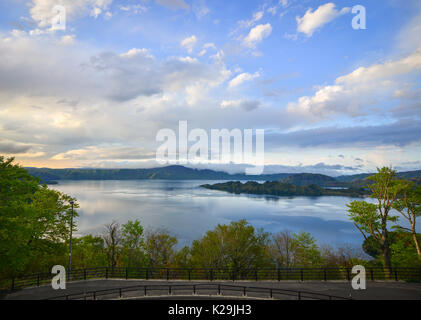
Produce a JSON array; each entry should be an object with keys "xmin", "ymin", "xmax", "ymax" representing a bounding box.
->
[{"xmin": 393, "ymin": 181, "xmax": 421, "ymax": 257}]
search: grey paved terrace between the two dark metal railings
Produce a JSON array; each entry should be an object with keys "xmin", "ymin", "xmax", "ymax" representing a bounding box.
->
[{"xmin": 4, "ymin": 279, "xmax": 421, "ymax": 300}]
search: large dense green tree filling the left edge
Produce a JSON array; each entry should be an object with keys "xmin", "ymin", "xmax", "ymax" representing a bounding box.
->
[{"xmin": 0, "ymin": 156, "xmax": 78, "ymax": 277}]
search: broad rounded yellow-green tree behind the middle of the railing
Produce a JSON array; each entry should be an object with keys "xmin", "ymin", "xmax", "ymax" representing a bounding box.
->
[{"xmin": 191, "ymin": 220, "xmax": 270, "ymax": 272}]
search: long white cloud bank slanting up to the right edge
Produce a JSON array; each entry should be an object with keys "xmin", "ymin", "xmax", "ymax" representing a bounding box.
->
[{"xmin": 288, "ymin": 48, "xmax": 421, "ymax": 118}]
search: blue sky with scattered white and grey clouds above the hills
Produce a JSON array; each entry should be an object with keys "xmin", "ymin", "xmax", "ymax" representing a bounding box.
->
[{"xmin": 0, "ymin": 0, "xmax": 421, "ymax": 175}]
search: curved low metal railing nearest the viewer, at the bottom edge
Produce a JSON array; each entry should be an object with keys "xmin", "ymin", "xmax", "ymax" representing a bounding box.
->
[{"xmin": 46, "ymin": 283, "xmax": 352, "ymax": 300}]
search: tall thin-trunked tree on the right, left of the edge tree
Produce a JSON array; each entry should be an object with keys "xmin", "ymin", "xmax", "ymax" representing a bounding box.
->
[{"xmin": 347, "ymin": 167, "xmax": 403, "ymax": 272}]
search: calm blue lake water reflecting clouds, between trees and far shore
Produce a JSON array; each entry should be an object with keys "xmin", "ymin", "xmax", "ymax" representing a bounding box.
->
[{"xmin": 51, "ymin": 180, "xmax": 392, "ymax": 246}]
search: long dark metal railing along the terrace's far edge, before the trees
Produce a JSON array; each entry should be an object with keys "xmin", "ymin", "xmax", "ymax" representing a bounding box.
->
[{"xmin": 4, "ymin": 267, "xmax": 421, "ymax": 291}]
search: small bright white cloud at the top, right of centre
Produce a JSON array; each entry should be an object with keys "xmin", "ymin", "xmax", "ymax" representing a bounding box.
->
[{"xmin": 296, "ymin": 2, "xmax": 351, "ymax": 37}]
